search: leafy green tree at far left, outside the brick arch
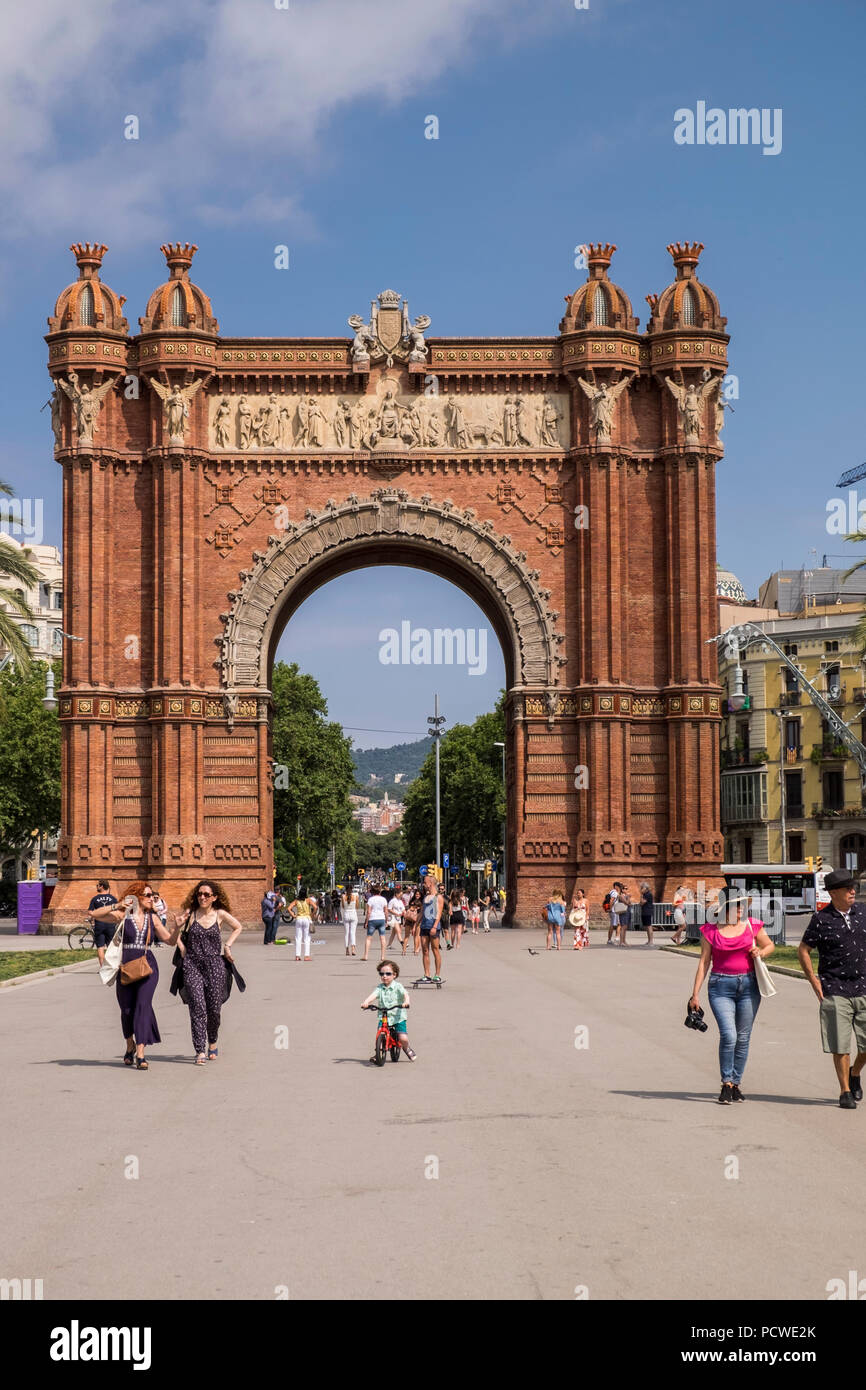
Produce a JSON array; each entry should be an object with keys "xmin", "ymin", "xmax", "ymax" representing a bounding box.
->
[{"xmin": 0, "ymin": 662, "xmax": 60, "ymax": 851}]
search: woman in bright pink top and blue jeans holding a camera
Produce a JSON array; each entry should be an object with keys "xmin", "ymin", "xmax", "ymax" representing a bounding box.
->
[{"xmin": 688, "ymin": 895, "xmax": 774, "ymax": 1105}]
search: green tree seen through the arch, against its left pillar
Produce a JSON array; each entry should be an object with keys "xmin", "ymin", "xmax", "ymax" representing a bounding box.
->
[{"xmin": 271, "ymin": 662, "xmax": 354, "ymax": 885}]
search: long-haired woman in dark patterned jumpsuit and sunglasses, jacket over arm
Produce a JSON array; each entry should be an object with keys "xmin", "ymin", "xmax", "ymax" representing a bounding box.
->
[{"xmin": 174, "ymin": 878, "xmax": 243, "ymax": 1066}]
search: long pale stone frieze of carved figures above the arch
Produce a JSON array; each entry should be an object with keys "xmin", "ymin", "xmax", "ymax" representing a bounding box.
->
[{"xmin": 209, "ymin": 379, "xmax": 570, "ymax": 453}]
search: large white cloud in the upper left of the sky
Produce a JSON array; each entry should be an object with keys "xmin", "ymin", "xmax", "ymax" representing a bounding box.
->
[{"xmin": 0, "ymin": 0, "xmax": 562, "ymax": 245}]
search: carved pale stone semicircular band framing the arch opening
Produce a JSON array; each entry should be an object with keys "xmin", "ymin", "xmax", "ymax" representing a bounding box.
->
[{"xmin": 217, "ymin": 488, "xmax": 564, "ymax": 692}]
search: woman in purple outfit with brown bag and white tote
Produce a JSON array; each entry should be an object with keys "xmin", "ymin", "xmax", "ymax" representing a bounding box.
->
[{"xmin": 92, "ymin": 881, "xmax": 181, "ymax": 1072}]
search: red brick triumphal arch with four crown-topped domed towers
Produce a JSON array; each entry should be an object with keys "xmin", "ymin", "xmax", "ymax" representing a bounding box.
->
[{"xmin": 43, "ymin": 243, "xmax": 728, "ymax": 930}]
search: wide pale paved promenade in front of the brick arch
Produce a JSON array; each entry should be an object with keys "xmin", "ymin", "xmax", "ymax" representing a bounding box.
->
[{"xmin": 0, "ymin": 927, "xmax": 866, "ymax": 1307}]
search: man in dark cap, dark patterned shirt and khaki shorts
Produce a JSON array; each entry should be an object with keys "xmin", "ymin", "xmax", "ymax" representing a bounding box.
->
[{"xmin": 796, "ymin": 869, "xmax": 866, "ymax": 1111}]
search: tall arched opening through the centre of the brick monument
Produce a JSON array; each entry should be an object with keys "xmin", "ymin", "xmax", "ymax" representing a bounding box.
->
[{"xmin": 268, "ymin": 564, "xmax": 507, "ymax": 901}]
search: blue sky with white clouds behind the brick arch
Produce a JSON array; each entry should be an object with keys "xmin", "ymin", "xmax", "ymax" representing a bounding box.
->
[{"xmin": 0, "ymin": 0, "xmax": 866, "ymax": 742}]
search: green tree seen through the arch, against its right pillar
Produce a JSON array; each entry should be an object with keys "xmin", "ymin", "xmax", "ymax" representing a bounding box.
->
[{"xmin": 403, "ymin": 695, "xmax": 505, "ymax": 867}]
